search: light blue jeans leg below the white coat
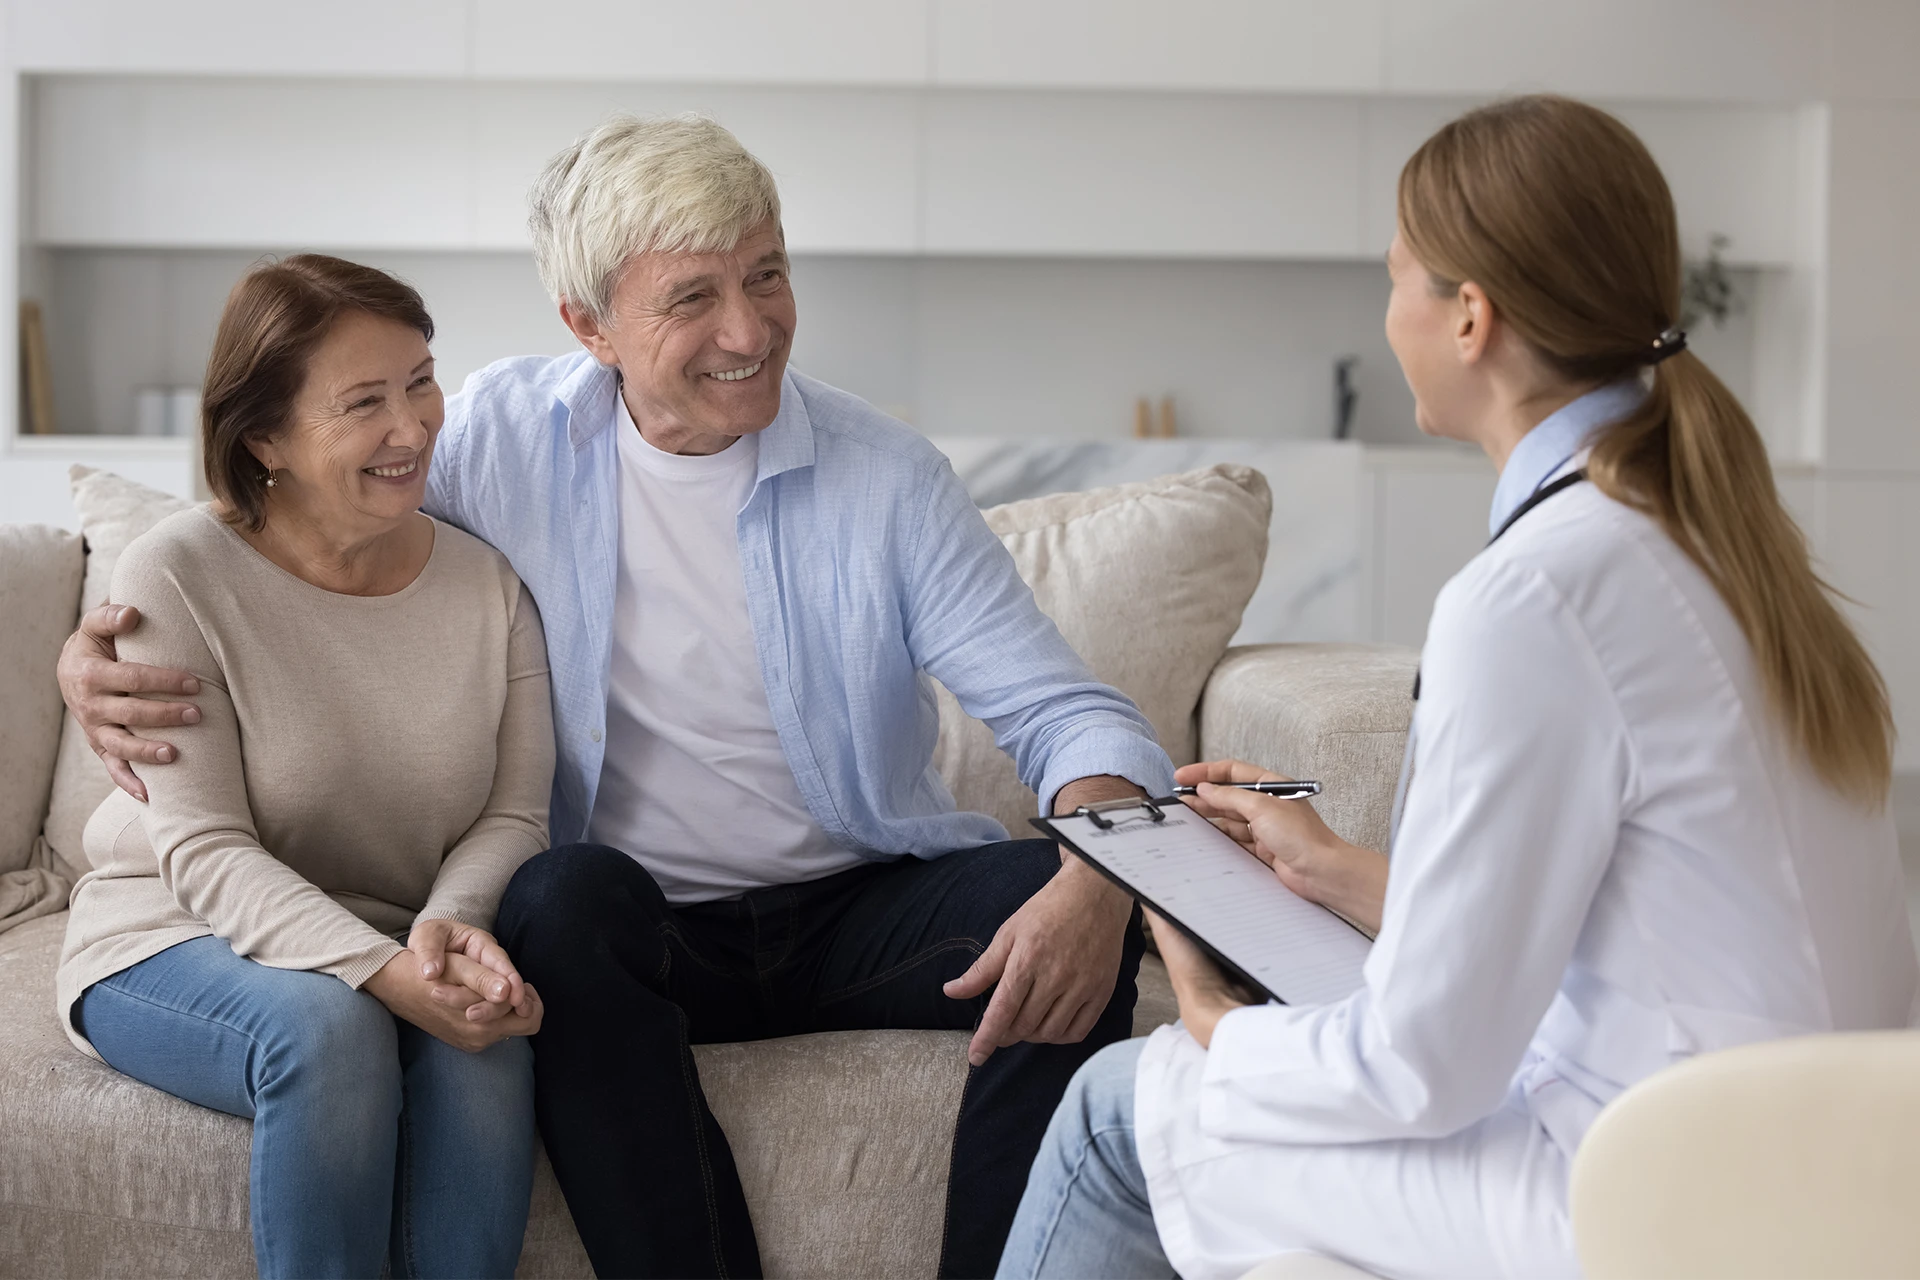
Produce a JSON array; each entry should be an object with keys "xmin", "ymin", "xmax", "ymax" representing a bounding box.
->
[{"xmin": 995, "ymin": 1040, "xmax": 1173, "ymax": 1280}]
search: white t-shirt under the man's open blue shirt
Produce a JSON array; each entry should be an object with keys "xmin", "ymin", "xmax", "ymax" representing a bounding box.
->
[{"xmin": 588, "ymin": 397, "xmax": 860, "ymax": 902}]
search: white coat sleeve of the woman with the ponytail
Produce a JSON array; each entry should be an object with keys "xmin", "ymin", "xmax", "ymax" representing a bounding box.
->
[{"xmin": 1200, "ymin": 564, "xmax": 1634, "ymax": 1144}]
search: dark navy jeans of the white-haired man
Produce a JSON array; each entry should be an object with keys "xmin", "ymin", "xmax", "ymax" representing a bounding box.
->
[{"xmin": 499, "ymin": 841, "xmax": 1142, "ymax": 1280}]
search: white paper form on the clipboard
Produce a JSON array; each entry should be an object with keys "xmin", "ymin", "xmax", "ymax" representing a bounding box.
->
[{"xmin": 1052, "ymin": 804, "xmax": 1373, "ymax": 1004}]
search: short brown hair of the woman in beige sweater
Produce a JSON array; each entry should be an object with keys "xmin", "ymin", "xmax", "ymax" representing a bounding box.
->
[{"xmin": 200, "ymin": 253, "xmax": 434, "ymax": 530}]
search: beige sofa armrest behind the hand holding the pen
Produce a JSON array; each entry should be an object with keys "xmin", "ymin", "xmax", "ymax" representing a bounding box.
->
[{"xmin": 1200, "ymin": 645, "xmax": 1419, "ymax": 852}]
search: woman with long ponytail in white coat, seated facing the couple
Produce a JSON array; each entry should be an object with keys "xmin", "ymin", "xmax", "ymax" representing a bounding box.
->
[{"xmin": 998, "ymin": 98, "xmax": 1920, "ymax": 1280}]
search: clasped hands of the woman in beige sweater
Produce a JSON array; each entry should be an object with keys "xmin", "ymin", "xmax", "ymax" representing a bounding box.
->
[{"xmin": 367, "ymin": 919, "xmax": 545, "ymax": 1054}]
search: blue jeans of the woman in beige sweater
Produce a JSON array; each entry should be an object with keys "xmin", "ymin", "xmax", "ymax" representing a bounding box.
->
[{"xmin": 73, "ymin": 938, "xmax": 534, "ymax": 1280}]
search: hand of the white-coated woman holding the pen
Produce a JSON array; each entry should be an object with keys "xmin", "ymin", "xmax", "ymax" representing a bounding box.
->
[{"xmin": 1173, "ymin": 760, "xmax": 1386, "ymax": 935}]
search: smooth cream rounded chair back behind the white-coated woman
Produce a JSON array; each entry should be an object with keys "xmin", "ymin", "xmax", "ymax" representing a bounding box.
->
[{"xmin": 1569, "ymin": 1031, "xmax": 1920, "ymax": 1280}]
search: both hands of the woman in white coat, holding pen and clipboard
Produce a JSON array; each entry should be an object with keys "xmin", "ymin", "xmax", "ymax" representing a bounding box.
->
[{"xmin": 1146, "ymin": 760, "xmax": 1386, "ymax": 1046}]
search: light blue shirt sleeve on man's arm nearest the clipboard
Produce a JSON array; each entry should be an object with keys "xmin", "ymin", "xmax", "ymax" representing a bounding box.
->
[{"xmin": 904, "ymin": 461, "xmax": 1173, "ymax": 814}]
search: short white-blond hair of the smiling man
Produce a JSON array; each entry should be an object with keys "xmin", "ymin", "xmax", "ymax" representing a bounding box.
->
[{"xmin": 526, "ymin": 113, "xmax": 780, "ymax": 324}]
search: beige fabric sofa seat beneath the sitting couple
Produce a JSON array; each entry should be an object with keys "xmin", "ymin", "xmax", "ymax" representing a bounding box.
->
[{"xmin": 0, "ymin": 913, "xmax": 1171, "ymax": 1280}]
